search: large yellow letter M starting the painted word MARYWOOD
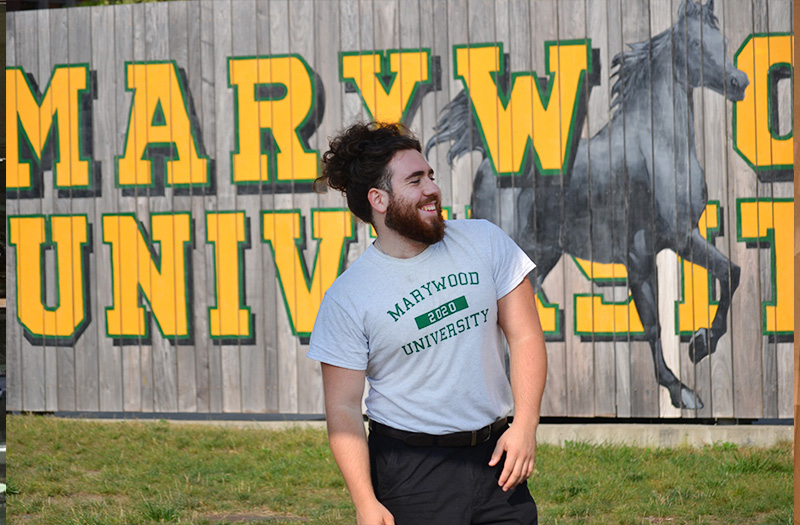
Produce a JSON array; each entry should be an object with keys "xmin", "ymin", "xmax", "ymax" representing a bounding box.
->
[{"xmin": 6, "ymin": 64, "xmax": 92, "ymax": 198}]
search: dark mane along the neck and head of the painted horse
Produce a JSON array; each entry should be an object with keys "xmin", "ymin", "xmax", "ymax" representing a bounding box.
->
[{"xmin": 611, "ymin": 0, "xmax": 719, "ymax": 109}]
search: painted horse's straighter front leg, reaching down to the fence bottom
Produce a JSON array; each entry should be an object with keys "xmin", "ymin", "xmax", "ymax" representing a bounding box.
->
[{"xmin": 628, "ymin": 230, "xmax": 703, "ymax": 410}]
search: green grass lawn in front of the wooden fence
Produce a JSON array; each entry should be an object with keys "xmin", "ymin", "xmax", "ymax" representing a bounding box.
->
[{"xmin": 7, "ymin": 415, "xmax": 793, "ymax": 525}]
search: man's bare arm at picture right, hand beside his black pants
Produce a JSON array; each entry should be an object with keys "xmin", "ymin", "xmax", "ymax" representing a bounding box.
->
[{"xmin": 489, "ymin": 278, "xmax": 547, "ymax": 491}]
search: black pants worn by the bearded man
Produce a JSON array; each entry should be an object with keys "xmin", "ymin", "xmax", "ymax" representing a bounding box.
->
[{"xmin": 369, "ymin": 424, "xmax": 538, "ymax": 525}]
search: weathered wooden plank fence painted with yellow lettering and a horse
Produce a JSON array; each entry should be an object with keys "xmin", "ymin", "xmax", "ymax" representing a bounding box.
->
[{"xmin": 6, "ymin": 0, "xmax": 794, "ymax": 418}]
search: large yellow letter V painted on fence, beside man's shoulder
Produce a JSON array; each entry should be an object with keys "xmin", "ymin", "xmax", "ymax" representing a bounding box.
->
[{"xmin": 261, "ymin": 209, "xmax": 355, "ymax": 341}]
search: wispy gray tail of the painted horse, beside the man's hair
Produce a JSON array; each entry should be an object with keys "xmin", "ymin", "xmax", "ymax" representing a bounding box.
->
[{"xmin": 425, "ymin": 90, "xmax": 486, "ymax": 166}]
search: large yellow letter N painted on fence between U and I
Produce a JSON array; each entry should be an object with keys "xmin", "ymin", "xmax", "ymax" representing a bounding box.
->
[{"xmin": 103, "ymin": 212, "xmax": 192, "ymax": 344}]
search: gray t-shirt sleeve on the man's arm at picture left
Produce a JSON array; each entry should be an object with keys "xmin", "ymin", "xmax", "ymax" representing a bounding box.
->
[{"xmin": 306, "ymin": 294, "xmax": 369, "ymax": 370}]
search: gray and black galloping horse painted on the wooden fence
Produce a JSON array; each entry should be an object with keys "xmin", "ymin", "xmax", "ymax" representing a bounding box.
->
[{"xmin": 426, "ymin": 0, "xmax": 749, "ymax": 409}]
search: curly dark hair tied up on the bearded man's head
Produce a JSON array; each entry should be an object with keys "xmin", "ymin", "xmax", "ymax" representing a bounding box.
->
[{"xmin": 314, "ymin": 122, "xmax": 422, "ymax": 223}]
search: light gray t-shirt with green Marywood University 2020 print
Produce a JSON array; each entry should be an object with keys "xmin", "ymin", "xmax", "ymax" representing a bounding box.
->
[{"xmin": 308, "ymin": 219, "xmax": 535, "ymax": 434}]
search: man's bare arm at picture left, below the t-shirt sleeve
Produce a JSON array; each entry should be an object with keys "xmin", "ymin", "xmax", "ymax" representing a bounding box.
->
[{"xmin": 322, "ymin": 363, "xmax": 394, "ymax": 525}]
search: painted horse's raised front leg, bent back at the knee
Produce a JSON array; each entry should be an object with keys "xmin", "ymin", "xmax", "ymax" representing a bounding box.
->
[{"xmin": 678, "ymin": 228, "xmax": 742, "ymax": 363}]
